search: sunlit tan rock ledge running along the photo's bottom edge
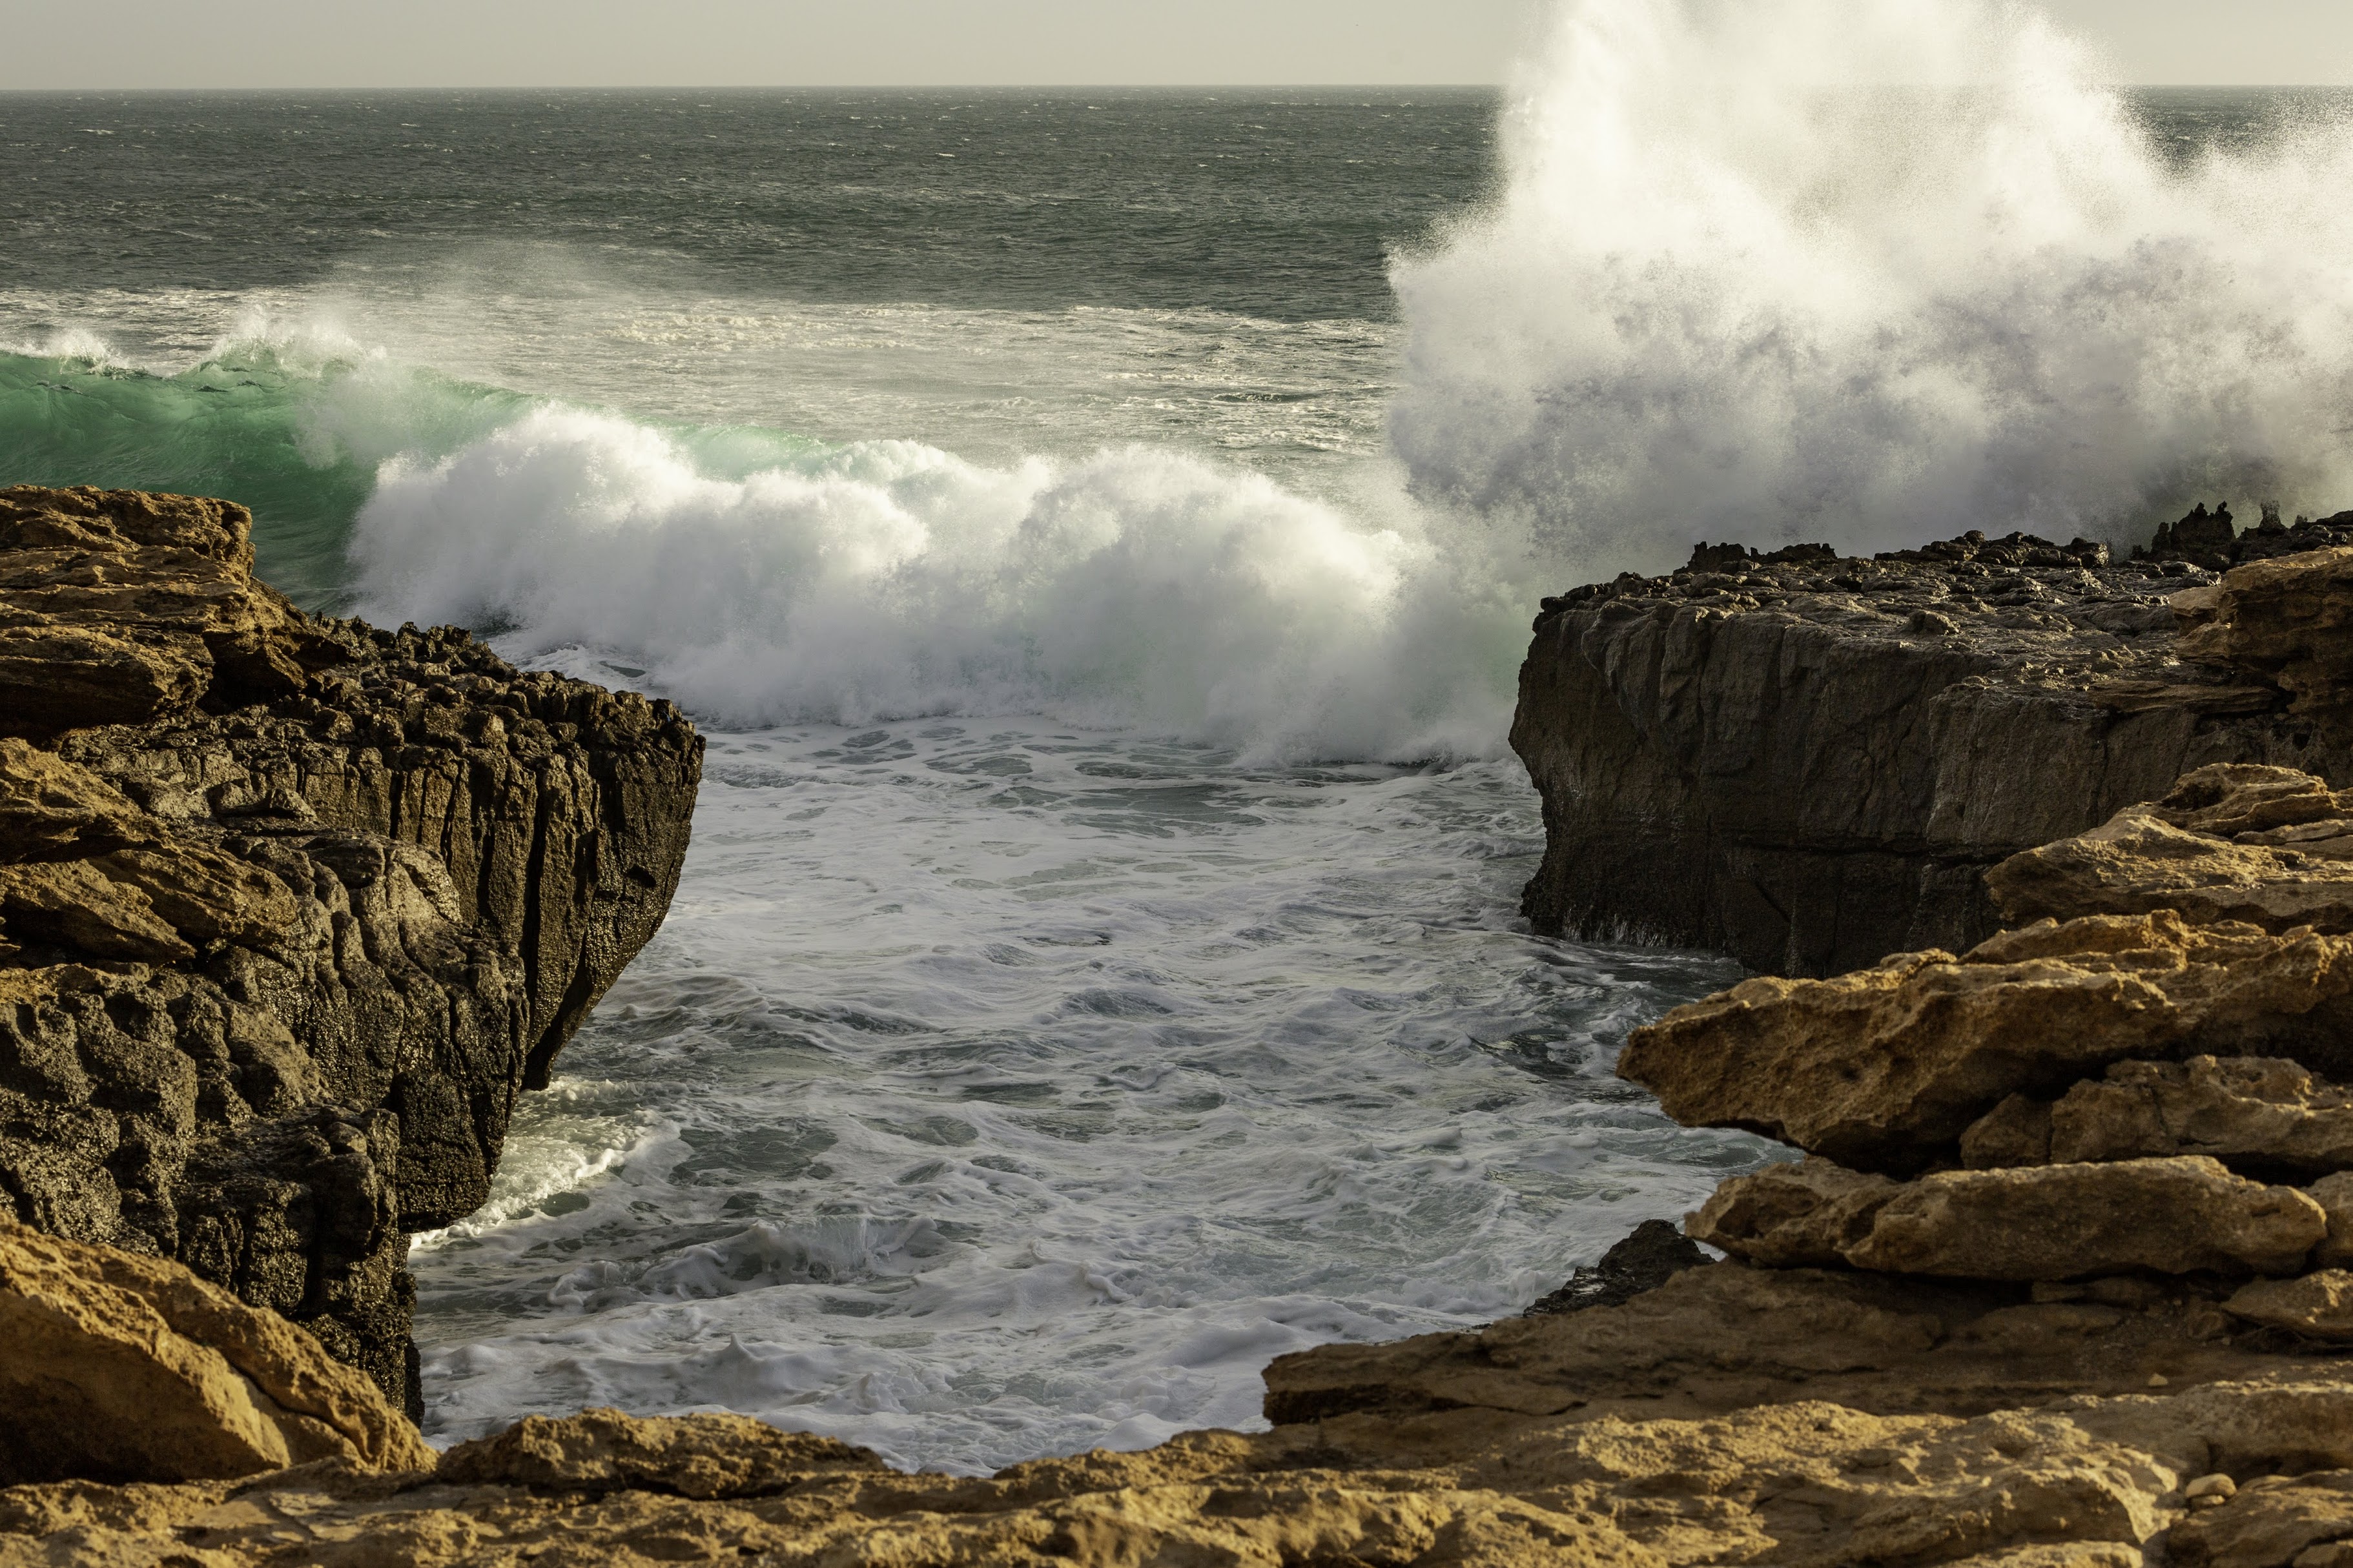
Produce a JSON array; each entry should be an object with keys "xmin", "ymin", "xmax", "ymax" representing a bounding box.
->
[{"xmin": 23, "ymin": 1382, "xmax": 2353, "ymax": 1568}]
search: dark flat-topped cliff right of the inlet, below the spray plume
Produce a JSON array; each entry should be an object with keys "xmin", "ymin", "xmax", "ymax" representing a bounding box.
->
[{"xmin": 1513, "ymin": 513, "xmax": 2353, "ymax": 975}]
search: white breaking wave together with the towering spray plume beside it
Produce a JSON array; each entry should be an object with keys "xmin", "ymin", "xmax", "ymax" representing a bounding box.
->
[{"xmin": 336, "ymin": 0, "xmax": 2353, "ymax": 759}]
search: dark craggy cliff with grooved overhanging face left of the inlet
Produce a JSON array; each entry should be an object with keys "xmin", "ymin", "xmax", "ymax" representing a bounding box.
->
[{"xmin": 0, "ymin": 487, "xmax": 701, "ymax": 1403}]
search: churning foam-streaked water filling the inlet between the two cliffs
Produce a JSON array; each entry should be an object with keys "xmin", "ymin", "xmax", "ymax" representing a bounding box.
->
[{"xmin": 414, "ymin": 724, "xmax": 1765, "ymax": 1469}]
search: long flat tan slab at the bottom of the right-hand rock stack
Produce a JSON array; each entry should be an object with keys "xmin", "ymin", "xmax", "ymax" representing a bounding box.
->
[{"xmin": 1687, "ymin": 1157, "xmax": 2327, "ymax": 1281}]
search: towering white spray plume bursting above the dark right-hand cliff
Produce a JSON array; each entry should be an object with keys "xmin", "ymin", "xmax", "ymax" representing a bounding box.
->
[{"xmin": 1391, "ymin": 0, "xmax": 2353, "ymax": 580}]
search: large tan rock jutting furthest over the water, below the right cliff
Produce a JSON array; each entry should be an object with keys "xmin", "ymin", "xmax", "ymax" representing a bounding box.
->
[{"xmin": 1619, "ymin": 910, "xmax": 2353, "ymax": 1173}]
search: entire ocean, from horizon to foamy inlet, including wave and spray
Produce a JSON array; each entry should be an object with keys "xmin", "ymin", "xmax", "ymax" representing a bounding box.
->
[{"xmin": 0, "ymin": 0, "xmax": 2353, "ymax": 1472}]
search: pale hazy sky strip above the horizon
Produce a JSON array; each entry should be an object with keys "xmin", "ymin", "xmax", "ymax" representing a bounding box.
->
[{"xmin": 0, "ymin": 0, "xmax": 2353, "ymax": 87}]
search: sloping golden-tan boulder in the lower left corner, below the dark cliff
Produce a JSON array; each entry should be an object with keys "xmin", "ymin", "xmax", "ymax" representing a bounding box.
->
[{"xmin": 0, "ymin": 1220, "xmax": 435, "ymax": 1481}]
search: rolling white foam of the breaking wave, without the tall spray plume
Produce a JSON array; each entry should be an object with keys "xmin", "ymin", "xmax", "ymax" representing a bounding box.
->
[{"xmin": 351, "ymin": 404, "xmax": 1517, "ymax": 757}]
